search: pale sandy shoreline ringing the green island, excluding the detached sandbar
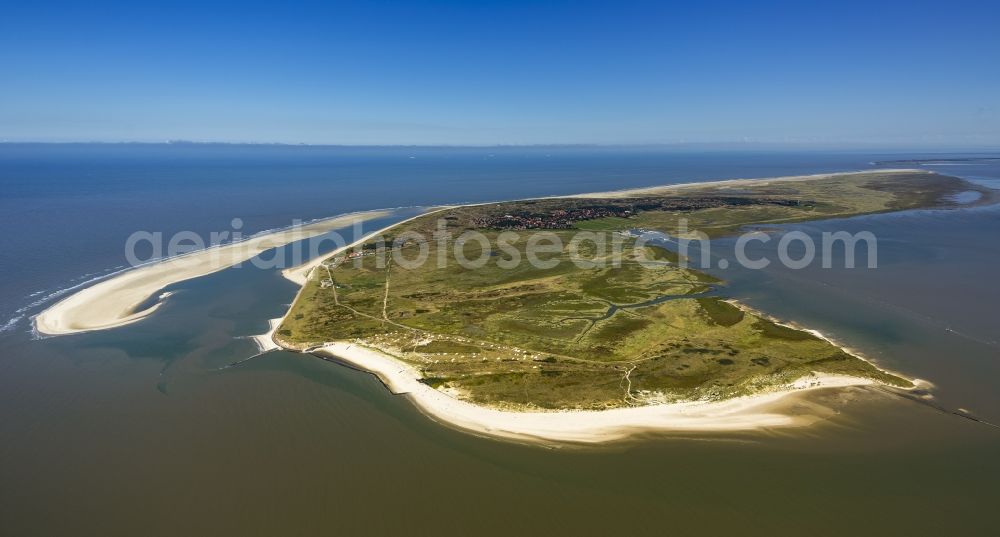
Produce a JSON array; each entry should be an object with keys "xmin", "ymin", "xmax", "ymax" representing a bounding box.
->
[{"xmin": 268, "ymin": 169, "xmax": 933, "ymax": 445}]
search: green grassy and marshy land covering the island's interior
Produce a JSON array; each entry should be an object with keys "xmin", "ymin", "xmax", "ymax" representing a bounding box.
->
[{"xmin": 276, "ymin": 173, "xmax": 982, "ymax": 409}]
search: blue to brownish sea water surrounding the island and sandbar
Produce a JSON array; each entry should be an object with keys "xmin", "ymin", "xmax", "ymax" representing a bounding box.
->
[{"xmin": 0, "ymin": 144, "xmax": 1000, "ymax": 537}]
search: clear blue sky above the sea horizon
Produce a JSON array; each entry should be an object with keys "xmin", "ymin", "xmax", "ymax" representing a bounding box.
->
[{"xmin": 0, "ymin": 0, "xmax": 1000, "ymax": 147}]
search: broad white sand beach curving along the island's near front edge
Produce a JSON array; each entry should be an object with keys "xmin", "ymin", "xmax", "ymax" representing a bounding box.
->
[{"xmin": 311, "ymin": 342, "xmax": 873, "ymax": 444}]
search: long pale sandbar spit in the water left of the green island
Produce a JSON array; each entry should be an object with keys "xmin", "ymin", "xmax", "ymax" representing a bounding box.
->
[{"xmin": 34, "ymin": 210, "xmax": 391, "ymax": 335}]
